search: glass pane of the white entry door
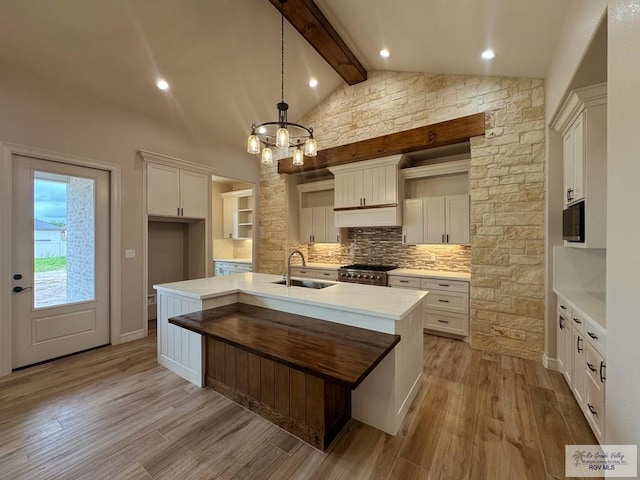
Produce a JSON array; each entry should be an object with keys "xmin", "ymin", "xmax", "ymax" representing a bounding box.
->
[{"xmin": 33, "ymin": 172, "xmax": 95, "ymax": 308}]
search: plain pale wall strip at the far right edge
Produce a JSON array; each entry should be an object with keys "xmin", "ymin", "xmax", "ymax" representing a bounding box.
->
[{"xmin": 605, "ymin": 0, "xmax": 640, "ymax": 445}]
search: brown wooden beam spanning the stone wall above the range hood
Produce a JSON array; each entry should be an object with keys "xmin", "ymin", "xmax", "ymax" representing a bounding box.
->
[{"xmin": 278, "ymin": 113, "xmax": 485, "ymax": 173}]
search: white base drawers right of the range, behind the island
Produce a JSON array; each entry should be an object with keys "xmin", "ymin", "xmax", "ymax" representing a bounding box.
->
[{"xmin": 388, "ymin": 274, "xmax": 469, "ymax": 337}]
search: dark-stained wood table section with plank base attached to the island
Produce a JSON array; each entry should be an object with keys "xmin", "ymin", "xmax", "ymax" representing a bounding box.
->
[{"xmin": 169, "ymin": 303, "xmax": 400, "ymax": 450}]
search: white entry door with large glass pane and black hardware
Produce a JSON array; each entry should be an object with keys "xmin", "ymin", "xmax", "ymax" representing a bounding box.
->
[{"xmin": 12, "ymin": 156, "xmax": 110, "ymax": 368}]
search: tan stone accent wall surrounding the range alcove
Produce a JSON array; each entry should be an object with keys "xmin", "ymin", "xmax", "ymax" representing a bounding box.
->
[{"xmin": 258, "ymin": 72, "xmax": 545, "ymax": 360}]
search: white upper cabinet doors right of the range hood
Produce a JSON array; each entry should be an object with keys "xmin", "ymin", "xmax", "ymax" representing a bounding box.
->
[{"xmin": 403, "ymin": 195, "xmax": 469, "ymax": 245}]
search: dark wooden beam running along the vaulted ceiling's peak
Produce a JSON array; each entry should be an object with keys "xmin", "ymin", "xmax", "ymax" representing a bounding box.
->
[{"xmin": 269, "ymin": 0, "xmax": 367, "ymax": 85}]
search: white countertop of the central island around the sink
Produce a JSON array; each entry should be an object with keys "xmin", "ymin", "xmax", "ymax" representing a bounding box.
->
[{"xmin": 153, "ymin": 273, "xmax": 427, "ymax": 320}]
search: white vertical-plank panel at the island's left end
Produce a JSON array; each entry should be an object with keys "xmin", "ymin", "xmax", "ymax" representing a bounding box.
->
[{"xmin": 157, "ymin": 289, "xmax": 237, "ymax": 387}]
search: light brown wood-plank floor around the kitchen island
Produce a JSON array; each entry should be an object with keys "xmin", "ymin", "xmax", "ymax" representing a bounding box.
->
[{"xmin": 0, "ymin": 328, "xmax": 595, "ymax": 480}]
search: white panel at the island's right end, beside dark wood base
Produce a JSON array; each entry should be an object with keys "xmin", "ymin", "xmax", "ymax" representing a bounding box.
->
[{"xmin": 351, "ymin": 305, "xmax": 423, "ymax": 435}]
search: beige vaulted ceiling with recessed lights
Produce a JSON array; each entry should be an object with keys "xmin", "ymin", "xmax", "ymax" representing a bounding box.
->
[{"xmin": 0, "ymin": 0, "xmax": 569, "ymax": 151}]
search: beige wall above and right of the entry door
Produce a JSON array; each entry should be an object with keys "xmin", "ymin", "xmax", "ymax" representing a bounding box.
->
[{"xmin": 0, "ymin": 66, "xmax": 258, "ymax": 334}]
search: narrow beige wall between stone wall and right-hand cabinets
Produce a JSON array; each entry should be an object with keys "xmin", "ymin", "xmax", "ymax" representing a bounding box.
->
[{"xmin": 544, "ymin": 0, "xmax": 607, "ymax": 359}]
